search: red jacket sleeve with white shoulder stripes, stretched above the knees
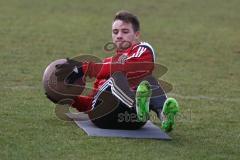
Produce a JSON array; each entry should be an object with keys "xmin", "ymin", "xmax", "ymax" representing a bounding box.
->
[{"xmin": 83, "ymin": 45, "xmax": 154, "ymax": 79}]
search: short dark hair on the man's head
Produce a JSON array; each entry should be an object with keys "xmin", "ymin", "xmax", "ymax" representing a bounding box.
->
[{"xmin": 113, "ymin": 10, "xmax": 140, "ymax": 32}]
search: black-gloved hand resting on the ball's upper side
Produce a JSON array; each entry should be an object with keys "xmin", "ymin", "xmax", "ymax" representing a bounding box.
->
[{"xmin": 55, "ymin": 58, "xmax": 84, "ymax": 84}]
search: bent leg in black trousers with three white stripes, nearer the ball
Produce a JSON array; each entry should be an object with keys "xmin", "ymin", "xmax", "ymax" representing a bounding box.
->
[{"xmin": 89, "ymin": 72, "xmax": 149, "ymax": 129}]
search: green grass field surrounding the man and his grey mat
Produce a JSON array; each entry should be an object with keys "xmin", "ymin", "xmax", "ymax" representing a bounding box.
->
[{"xmin": 0, "ymin": 0, "xmax": 240, "ymax": 160}]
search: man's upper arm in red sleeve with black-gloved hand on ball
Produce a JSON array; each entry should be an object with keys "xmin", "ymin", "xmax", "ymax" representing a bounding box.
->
[{"xmin": 56, "ymin": 45, "xmax": 154, "ymax": 84}]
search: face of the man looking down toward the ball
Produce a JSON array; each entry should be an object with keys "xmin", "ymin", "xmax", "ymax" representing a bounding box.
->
[{"xmin": 112, "ymin": 20, "xmax": 140, "ymax": 50}]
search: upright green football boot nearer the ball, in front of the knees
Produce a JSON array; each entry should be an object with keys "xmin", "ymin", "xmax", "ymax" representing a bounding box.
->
[{"xmin": 136, "ymin": 81, "xmax": 152, "ymax": 122}]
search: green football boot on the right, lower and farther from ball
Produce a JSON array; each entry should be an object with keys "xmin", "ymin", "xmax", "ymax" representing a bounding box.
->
[{"xmin": 161, "ymin": 98, "xmax": 179, "ymax": 132}]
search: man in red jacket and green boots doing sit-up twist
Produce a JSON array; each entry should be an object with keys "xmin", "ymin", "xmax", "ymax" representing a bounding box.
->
[{"xmin": 50, "ymin": 11, "xmax": 179, "ymax": 131}]
